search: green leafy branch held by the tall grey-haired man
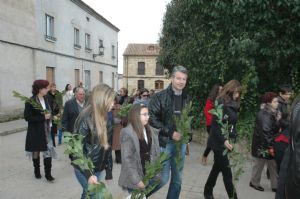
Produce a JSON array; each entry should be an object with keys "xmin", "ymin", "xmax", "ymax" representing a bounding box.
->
[{"xmin": 174, "ymin": 102, "xmax": 193, "ymax": 170}]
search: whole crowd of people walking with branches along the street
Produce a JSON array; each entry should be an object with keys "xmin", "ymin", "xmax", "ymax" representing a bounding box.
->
[{"xmin": 24, "ymin": 66, "xmax": 300, "ymax": 199}]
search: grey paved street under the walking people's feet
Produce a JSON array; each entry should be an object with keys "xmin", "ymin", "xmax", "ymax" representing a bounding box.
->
[{"xmin": 0, "ymin": 131, "xmax": 275, "ymax": 199}]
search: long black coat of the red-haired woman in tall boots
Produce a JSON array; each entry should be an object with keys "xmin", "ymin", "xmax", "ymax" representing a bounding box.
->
[{"xmin": 24, "ymin": 96, "xmax": 51, "ymax": 152}]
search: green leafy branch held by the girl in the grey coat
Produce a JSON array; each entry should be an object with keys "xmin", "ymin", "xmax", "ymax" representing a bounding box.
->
[{"xmin": 131, "ymin": 153, "xmax": 169, "ymax": 199}]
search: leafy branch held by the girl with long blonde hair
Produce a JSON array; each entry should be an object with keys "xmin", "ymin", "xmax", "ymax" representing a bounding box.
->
[{"xmin": 63, "ymin": 132, "xmax": 112, "ymax": 199}]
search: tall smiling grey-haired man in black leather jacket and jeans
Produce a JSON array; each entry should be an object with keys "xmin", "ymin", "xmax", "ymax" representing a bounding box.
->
[{"xmin": 149, "ymin": 66, "xmax": 188, "ymax": 199}]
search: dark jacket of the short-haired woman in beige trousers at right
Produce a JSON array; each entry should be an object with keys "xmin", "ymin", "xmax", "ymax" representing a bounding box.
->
[{"xmin": 251, "ymin": 105, "xmax": 279, "ymax": 159}]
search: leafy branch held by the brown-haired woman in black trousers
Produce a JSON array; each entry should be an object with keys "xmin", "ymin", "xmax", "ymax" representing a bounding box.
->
[{"xmin": 209, "ymin": 101, "xmax": 246, "ymax": 198}]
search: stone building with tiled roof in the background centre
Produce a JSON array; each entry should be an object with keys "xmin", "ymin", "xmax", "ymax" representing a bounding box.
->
[{"xmin": 123, "ymin": 44, "xmax": 170, "ymax": 92}]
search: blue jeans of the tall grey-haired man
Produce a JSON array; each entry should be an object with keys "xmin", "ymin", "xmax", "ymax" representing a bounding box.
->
[{"xmin": 147, "ymin": 140, "xmax": 186, "ymax": 199}]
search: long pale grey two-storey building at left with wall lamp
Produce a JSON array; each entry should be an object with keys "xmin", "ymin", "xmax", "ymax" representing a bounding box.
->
[{"xmin": 0, "ymin": 0, "xmax": 119, "ymax": 112}]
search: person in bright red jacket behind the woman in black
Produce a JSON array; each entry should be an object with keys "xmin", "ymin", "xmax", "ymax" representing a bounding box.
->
[{"xmin": 202, "ymin": 84, "xmax": 222, "ymax": 164}]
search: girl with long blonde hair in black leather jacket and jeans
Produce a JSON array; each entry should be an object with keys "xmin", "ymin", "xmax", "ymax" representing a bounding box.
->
[{"xmin": 73, "ymin": 84, "xmax": 115, "ymax": 199}]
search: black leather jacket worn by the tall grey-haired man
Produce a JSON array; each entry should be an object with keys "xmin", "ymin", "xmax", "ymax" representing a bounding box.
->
[{"xmin": 148, "ymin": 85, "xmax": 189, "ymax": 147}]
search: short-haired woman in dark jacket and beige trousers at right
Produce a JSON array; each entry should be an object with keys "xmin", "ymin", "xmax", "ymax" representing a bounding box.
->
[{"xmin": 250, "ymin": 92, "xmax": 280, "ymax": 192}]
